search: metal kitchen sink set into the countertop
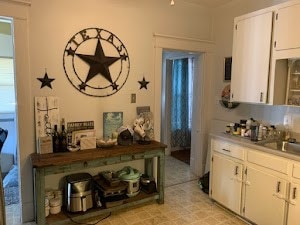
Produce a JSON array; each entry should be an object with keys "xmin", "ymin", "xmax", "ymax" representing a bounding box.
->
[{"xmin": 256, "ymin": 140, "xmax": 300, "ymax": 154}]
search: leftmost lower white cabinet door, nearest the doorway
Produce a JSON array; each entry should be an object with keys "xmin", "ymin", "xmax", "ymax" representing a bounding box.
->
[{"xmin": 211, "ymin": 154, "xmax": 243, "ymax": 214}]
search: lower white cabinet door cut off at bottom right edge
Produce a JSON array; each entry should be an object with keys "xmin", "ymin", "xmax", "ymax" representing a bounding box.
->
[{"xmin": 287, "ymin": 183, "xmax": 300, "ymax": 225}]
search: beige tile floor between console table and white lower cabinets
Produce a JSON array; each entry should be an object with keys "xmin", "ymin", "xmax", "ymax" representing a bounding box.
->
[{"xmin": 6, "ymin": 156, "xmax": 247, "ymax": 225}]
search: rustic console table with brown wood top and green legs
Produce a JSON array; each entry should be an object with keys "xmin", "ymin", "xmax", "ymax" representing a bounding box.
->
[{"xmin": 31, "ymin": 141, "xmax": 166, "ymax": 225}]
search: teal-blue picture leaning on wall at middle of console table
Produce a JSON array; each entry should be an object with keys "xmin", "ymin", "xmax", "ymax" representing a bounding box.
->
[{"xmin": 103, "ymin": 112, "xmax": 123, "ymax": 140}]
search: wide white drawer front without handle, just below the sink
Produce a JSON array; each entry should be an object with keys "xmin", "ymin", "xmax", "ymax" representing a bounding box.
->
[{"xmin": 247, "ymin": 151, "xmax": 288, "ymax": 174}]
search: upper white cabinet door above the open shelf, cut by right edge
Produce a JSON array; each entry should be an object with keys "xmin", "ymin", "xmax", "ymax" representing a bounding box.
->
[{"xmin": 275, "ymin": 4, "xmax": 300, "ymax": 50}]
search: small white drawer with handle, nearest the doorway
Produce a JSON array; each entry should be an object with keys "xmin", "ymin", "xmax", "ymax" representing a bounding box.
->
[{"xmin": 212, "ymin": 139, "xmax": 244, "ymax": 160}]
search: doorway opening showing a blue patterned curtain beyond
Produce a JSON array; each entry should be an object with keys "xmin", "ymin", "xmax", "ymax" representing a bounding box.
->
[{"xmin": 162, "ymin": 50, "xmax": 199, "ymax": 165}]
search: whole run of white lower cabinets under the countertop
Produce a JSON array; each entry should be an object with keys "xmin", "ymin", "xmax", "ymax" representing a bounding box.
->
[{"xmin": 210, "ymin": 138, "xmax": 300, "ymax": 225}]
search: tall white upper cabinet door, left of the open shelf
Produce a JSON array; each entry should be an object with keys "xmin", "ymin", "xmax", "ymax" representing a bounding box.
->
[{"xmin": 231, "ymin": 12, "xmax": 273, "ymax": 103}]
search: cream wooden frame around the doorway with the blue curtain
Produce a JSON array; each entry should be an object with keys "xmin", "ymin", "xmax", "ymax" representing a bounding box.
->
[{"xmin": 153, "ymin": 34, "xmax": 215, "ymax": 176}]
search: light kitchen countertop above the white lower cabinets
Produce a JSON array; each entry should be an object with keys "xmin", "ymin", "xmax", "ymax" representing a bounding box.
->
[{"xmin": 210, "ymin": 132, "xmax": 300, "ymax": 162}]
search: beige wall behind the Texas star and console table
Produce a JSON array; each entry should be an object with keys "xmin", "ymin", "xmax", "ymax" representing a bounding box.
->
[{"xmin": 10, "ymin": 0, "xmax": 212, "ymax": 221}]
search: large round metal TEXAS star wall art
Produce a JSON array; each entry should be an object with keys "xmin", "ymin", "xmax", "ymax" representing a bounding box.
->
[{"xmin": 63, "ymin": 28, "xmax": 130, "ymax": 97}]
